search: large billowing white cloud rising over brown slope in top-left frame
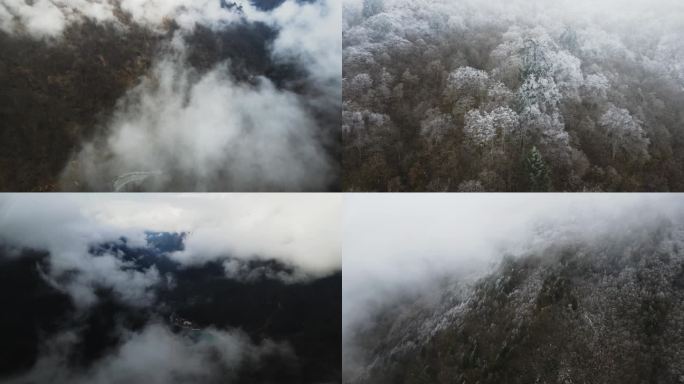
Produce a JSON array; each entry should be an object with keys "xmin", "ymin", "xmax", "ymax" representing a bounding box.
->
[{"xmin": 63, "ymin": 59, "xmax": 334, "ymax": 191}]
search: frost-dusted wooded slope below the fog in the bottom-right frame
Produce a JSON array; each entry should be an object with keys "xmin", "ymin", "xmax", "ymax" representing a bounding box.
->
[{"xmin": 344, "ymin": 221, "xmax": 684, "ymax": 384}]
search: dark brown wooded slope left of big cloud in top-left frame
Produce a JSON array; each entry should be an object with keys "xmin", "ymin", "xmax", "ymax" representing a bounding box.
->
[{"xmin": 0, "ymin": 22, "xmax": 159, "ymax": 191}]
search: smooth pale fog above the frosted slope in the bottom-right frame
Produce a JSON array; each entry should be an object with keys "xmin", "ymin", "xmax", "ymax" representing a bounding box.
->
[{"xmin": 342, "ymin": 194, "xmax": 684, "ymax": 369}]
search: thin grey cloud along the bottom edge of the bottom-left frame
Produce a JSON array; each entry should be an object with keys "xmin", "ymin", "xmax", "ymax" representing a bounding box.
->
[{"xmin": 7, "ymin": 323, "xmax": 294, "ymax": 384}]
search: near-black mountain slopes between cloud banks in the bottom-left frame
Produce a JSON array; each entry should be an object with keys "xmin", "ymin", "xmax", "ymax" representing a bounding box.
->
[{"xmin": 0, "ymin": 232, "xmax": 341, "ymax": 383}]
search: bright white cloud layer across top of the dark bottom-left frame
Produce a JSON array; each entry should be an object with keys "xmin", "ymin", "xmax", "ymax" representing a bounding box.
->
[{"xmin": 0, "ymin": 194, "xmax": 341, "ymax": 307}]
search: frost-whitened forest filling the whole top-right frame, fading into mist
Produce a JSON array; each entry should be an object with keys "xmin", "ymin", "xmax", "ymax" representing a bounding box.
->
[{"xmin": 342, "ymin": 0, "xmax": 684, "ymax": 192}]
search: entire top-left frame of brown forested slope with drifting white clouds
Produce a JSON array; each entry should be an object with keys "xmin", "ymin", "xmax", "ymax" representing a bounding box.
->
[{"xmin": 0, "ymin": 0, "xmax": 341, "ymax": 192}]
